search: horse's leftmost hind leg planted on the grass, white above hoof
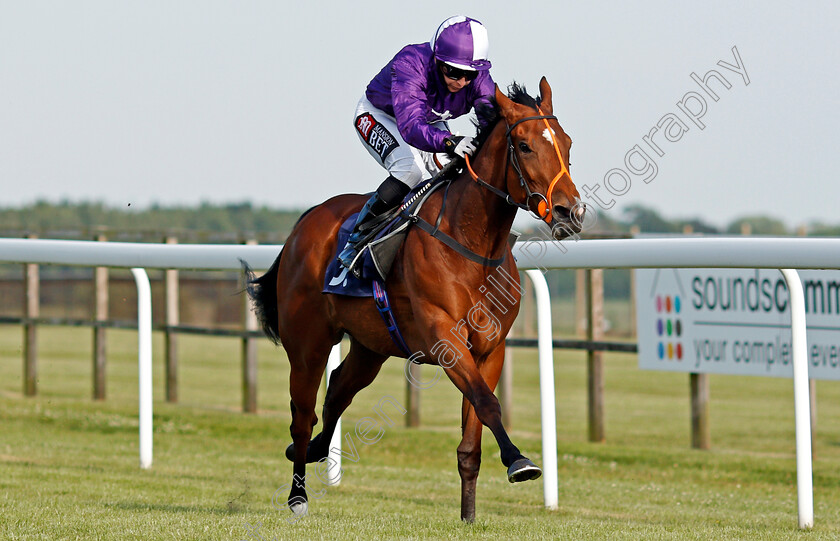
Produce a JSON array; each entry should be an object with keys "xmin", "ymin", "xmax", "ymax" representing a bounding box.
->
[{"xmin": 287, "ymin": 340, "xmax": 330, "ymax": 515}]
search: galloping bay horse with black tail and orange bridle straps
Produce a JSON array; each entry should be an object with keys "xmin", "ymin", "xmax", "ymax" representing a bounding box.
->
[{"xmin": 245, "ymin": 77, "xmax": 584, "ymax": 522}]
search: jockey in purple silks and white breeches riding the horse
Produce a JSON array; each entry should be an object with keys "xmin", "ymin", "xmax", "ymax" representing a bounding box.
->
[{"xmin": 338, "ymin": 16, "xmax": 496, "ymax": 268}]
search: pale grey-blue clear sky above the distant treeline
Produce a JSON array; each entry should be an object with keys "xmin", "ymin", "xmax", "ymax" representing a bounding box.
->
[{"xmin": 0, "ymin": 0, "xmax": 840, "ymax": 227}]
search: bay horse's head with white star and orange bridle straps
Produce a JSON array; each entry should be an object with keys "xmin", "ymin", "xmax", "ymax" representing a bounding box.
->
[{"xmin": 496, "ymin": 77, "xmax": 585, "ymax": 240}]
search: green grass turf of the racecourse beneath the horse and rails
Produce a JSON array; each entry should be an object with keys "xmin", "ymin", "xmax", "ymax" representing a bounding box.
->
[{"xmin": 0, "ymin": 326, "xmax": 840, "ymax": 540}]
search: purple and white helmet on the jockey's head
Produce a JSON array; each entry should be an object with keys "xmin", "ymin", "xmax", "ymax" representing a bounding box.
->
[{"xmin": 431, "ymin": 15, "xmax": 490, "ymax": 71}]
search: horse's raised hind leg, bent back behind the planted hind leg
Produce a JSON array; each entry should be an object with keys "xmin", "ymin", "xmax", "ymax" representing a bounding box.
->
[{"xmin": 307, "ymin": 338, "xmax": 388, "ymax": 462}]
